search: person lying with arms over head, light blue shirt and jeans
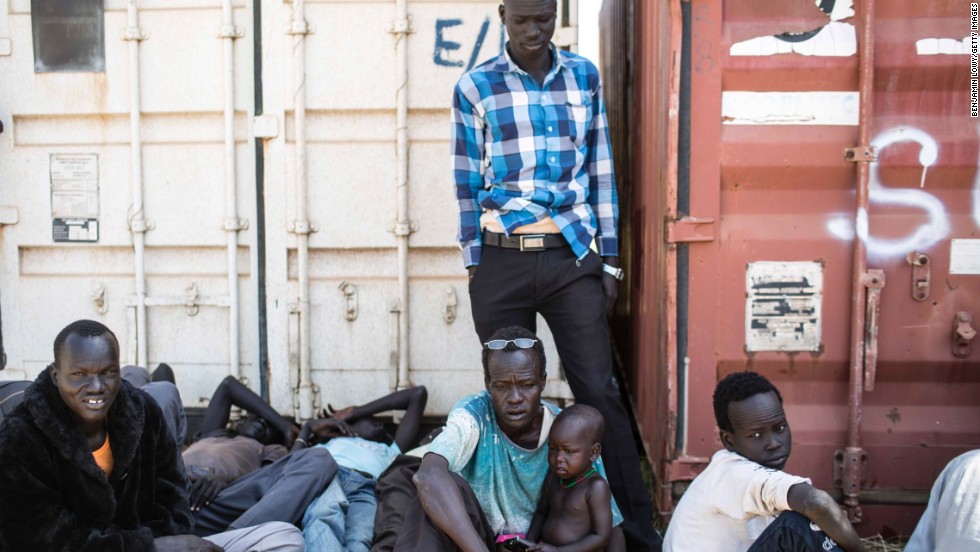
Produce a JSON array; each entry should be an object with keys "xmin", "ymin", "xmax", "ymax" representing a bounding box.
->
[{"xmin": 293, "ymin": 385, "xmax": 428, "ymax": 552}]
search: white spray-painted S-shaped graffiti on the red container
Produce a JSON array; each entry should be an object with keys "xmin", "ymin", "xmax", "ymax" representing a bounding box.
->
[{"xmin": 827, "ymin": 126, "xmax": 956, "ymax": 258}]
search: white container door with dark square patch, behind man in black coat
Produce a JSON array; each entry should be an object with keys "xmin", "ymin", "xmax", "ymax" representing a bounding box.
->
[{"xmin": 0, "ymin": 0, "xmax": 258, "ymax": 406}]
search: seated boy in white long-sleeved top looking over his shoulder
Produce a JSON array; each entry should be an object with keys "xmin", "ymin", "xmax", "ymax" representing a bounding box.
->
[{"xmin": 664, "ymin": 372, "xmax": 864, "ymax": 552}]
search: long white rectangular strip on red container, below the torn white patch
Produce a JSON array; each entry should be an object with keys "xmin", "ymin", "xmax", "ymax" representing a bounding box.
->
[{"xmin": 721, "ymin": 90, "xmax": 860, "ymax": 126}]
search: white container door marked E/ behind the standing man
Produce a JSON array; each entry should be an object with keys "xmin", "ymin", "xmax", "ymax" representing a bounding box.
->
[{"xmin": 261, "ymin": 1, "xmax": 577, "ymax": 416}]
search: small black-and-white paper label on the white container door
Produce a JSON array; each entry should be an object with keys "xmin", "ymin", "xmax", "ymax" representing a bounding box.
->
[{"xmin": 50, "ymin": 153, "xmax": 99, "ymax": 242}]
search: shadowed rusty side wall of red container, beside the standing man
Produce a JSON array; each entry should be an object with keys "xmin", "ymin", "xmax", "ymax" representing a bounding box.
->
[{"xmin": 601, "ymin": 0, "xmax": 681, "ymax": 510}]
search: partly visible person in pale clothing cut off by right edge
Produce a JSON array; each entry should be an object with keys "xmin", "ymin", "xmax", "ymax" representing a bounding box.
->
[{"xmin": 905, "ymin": 449, "xmax": 980, "ymax": 552}]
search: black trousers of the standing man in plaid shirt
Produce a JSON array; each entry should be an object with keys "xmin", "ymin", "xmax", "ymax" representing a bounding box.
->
[{"xmin": 470, "ymin": 245, "xmax": 661, "ymax": 551}]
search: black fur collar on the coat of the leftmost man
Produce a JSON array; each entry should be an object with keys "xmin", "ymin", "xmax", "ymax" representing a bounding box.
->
[{"xmin": 24, "ymin": 368, "xmax": 145, "ymax": 480}]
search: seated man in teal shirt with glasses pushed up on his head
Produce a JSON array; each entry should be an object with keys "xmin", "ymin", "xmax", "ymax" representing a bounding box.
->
[{"xmin": 382, "ymin": 327, "xmax": 622, "ymax": 552}]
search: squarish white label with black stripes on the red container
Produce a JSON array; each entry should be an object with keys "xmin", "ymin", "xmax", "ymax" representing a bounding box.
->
[{"xmin": 745, "ymin": 261, "xmax": 823, "ymax": 352}]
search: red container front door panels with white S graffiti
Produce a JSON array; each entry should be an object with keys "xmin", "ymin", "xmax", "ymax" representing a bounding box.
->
[{"xmin": 652, "ymin": 0, "xmax": 980, "ymax": 534}]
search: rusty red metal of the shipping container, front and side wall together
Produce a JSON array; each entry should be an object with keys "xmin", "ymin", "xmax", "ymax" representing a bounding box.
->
[{"xmin": 604, "ymin": 0, "xmax": 980, "ymax": 534}]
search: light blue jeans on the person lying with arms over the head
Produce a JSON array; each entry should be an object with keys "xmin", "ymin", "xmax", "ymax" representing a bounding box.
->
[{"xmin": 303, "ymin": 466, "xmax": 378, "ymax": 552}]
